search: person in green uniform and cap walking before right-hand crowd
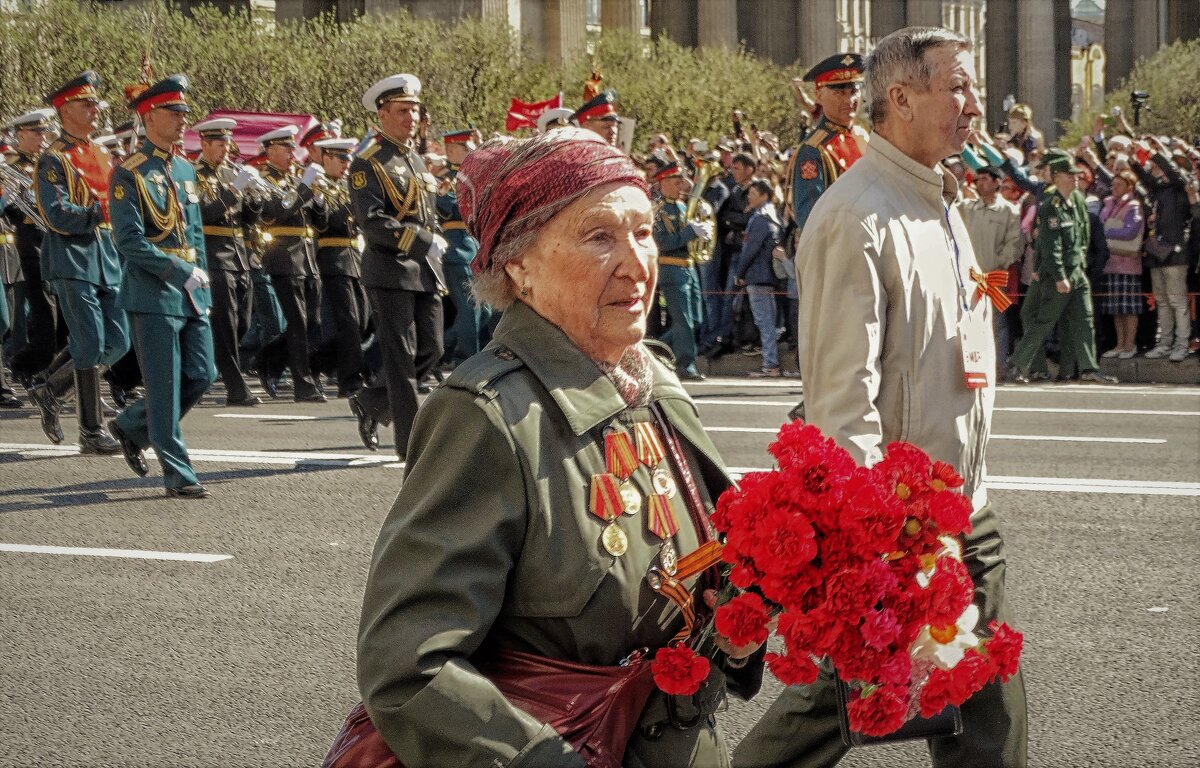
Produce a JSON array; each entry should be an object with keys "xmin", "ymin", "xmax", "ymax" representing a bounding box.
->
[{"xmin": 1012, "ymin": 149, "xmax": 1116, "ymax": 384}]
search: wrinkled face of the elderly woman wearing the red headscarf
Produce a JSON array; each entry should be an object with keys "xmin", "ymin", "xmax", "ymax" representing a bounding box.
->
[{"xmin": 505, "ymin": 184, "xmax": 659, "ymax": 364}]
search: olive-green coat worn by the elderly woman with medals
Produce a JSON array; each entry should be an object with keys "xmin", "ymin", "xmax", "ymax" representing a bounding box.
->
[{"xmin": 358, "ymin": 301, "xmax": 762, "ymax": 768}]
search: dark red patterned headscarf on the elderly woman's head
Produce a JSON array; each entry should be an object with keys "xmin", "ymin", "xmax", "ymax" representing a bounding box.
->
[{"xmin": 456, "ymin": 128, "xmax": 649, "ymax": 275}]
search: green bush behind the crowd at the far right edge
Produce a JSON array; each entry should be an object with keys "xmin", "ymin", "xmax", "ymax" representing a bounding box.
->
[{"xmin": 1060, "ymin": 40, "xmax": 1200, "ymax": 146}]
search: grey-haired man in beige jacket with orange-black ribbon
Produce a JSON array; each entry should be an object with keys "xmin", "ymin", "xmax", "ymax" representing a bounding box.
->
[{"xmin": 733, "ymin": 28, "xmax": 1026, "ymax": 768}]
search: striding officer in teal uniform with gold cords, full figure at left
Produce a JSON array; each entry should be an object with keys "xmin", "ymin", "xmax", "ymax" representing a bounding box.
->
[{"xmin": 109, "ymin": 74, "xmax": 216, "ymax": 499}]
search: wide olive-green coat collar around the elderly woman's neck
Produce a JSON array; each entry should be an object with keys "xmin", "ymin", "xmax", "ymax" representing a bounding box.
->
[{"xmin": 494, "ymin": 301, "xmax": 691, "ymax": 434}]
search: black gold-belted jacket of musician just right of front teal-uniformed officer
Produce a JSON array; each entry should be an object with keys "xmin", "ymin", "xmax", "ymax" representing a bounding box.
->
[{"xmin": 194, "ymin": 160, "xmax": 263, "ymax": 272}]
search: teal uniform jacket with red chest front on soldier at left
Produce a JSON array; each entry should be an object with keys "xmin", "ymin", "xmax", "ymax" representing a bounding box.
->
[{"xmin": 34, "ymin": 133, "xmax": 121, "ymax": 288}]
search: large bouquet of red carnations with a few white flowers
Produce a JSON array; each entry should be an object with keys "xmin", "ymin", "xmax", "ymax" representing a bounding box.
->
[{"xmin": 713, "ymin": 421, "xmax": 1022, "ymax": 736}]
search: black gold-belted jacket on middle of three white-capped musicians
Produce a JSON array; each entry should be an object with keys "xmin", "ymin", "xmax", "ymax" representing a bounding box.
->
[{"xmin": 262, "ymin": 163, "xmax": 328, "ymax": 277}]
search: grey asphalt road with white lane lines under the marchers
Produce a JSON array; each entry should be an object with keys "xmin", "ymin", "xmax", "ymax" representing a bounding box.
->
[{"xmin": 0, "ymin": 379, "xmax": 1200, "ymax": 768}]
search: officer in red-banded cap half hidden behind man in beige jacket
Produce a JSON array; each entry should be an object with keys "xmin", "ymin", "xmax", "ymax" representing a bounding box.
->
[{"xmin": 784, "ymin": 53, "xmax": 863, "ymax": 236}]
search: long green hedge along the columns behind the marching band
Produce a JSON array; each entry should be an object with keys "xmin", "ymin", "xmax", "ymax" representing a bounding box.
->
[{"xmin": 0, "ymin": 0, "xmax": 797, "ymax": 146}]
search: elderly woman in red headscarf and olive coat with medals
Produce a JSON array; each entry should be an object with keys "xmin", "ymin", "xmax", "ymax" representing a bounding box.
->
[{"xmin": 359, "ymin": 128, "xmax": 762, "ymax": 768}]
